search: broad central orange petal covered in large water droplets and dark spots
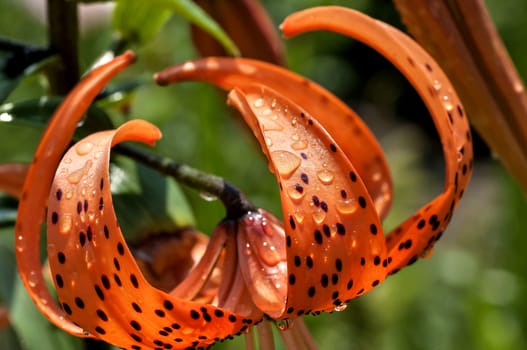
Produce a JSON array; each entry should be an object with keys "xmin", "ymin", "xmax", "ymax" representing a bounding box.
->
[{"xmin": 229, "ymin": 84, "xmax": 386, "ymax": 318}]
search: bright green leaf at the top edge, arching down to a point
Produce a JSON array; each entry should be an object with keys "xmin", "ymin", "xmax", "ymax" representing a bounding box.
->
[{"xmin": 113, "ymin": 0, "xmax": 240, "ymax": 56}]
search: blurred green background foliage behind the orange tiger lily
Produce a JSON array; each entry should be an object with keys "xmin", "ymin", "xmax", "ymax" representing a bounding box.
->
[{"xmin": 0, "ymin": 0, "xmax": 527, "ymax": 350}]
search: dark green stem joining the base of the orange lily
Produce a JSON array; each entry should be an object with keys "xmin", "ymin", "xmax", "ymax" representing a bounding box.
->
[{"xmin": 114, "ymin": 144, "xmax": 256, "ymax": 220}]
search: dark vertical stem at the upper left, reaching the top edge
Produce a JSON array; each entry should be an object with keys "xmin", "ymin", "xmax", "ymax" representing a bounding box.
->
[{"xmin": 47, "ymin": 0, "xmax": 80, "ymax": 95}]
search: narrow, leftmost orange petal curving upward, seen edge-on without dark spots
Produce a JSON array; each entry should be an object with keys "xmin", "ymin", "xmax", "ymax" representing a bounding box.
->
[{"xmin": 15, "ymin": 52, "xmax": 135, "ymax": 336}]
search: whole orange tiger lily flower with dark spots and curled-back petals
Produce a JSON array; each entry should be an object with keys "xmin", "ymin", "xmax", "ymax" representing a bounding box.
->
[{"xmin": 16, "ymin": 7, "xmax": 472, "ymax": 349}]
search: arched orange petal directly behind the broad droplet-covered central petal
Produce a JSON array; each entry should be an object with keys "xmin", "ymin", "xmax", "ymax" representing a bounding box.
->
[{"xmin": 156, "ymin": 57, "xmax": 392, "ymax": 217}]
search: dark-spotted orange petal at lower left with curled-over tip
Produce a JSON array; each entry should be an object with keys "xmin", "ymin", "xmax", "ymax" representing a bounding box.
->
[{"xmin": 48, "ymin": 120, "xmax": 256, "ymax": 349}]
